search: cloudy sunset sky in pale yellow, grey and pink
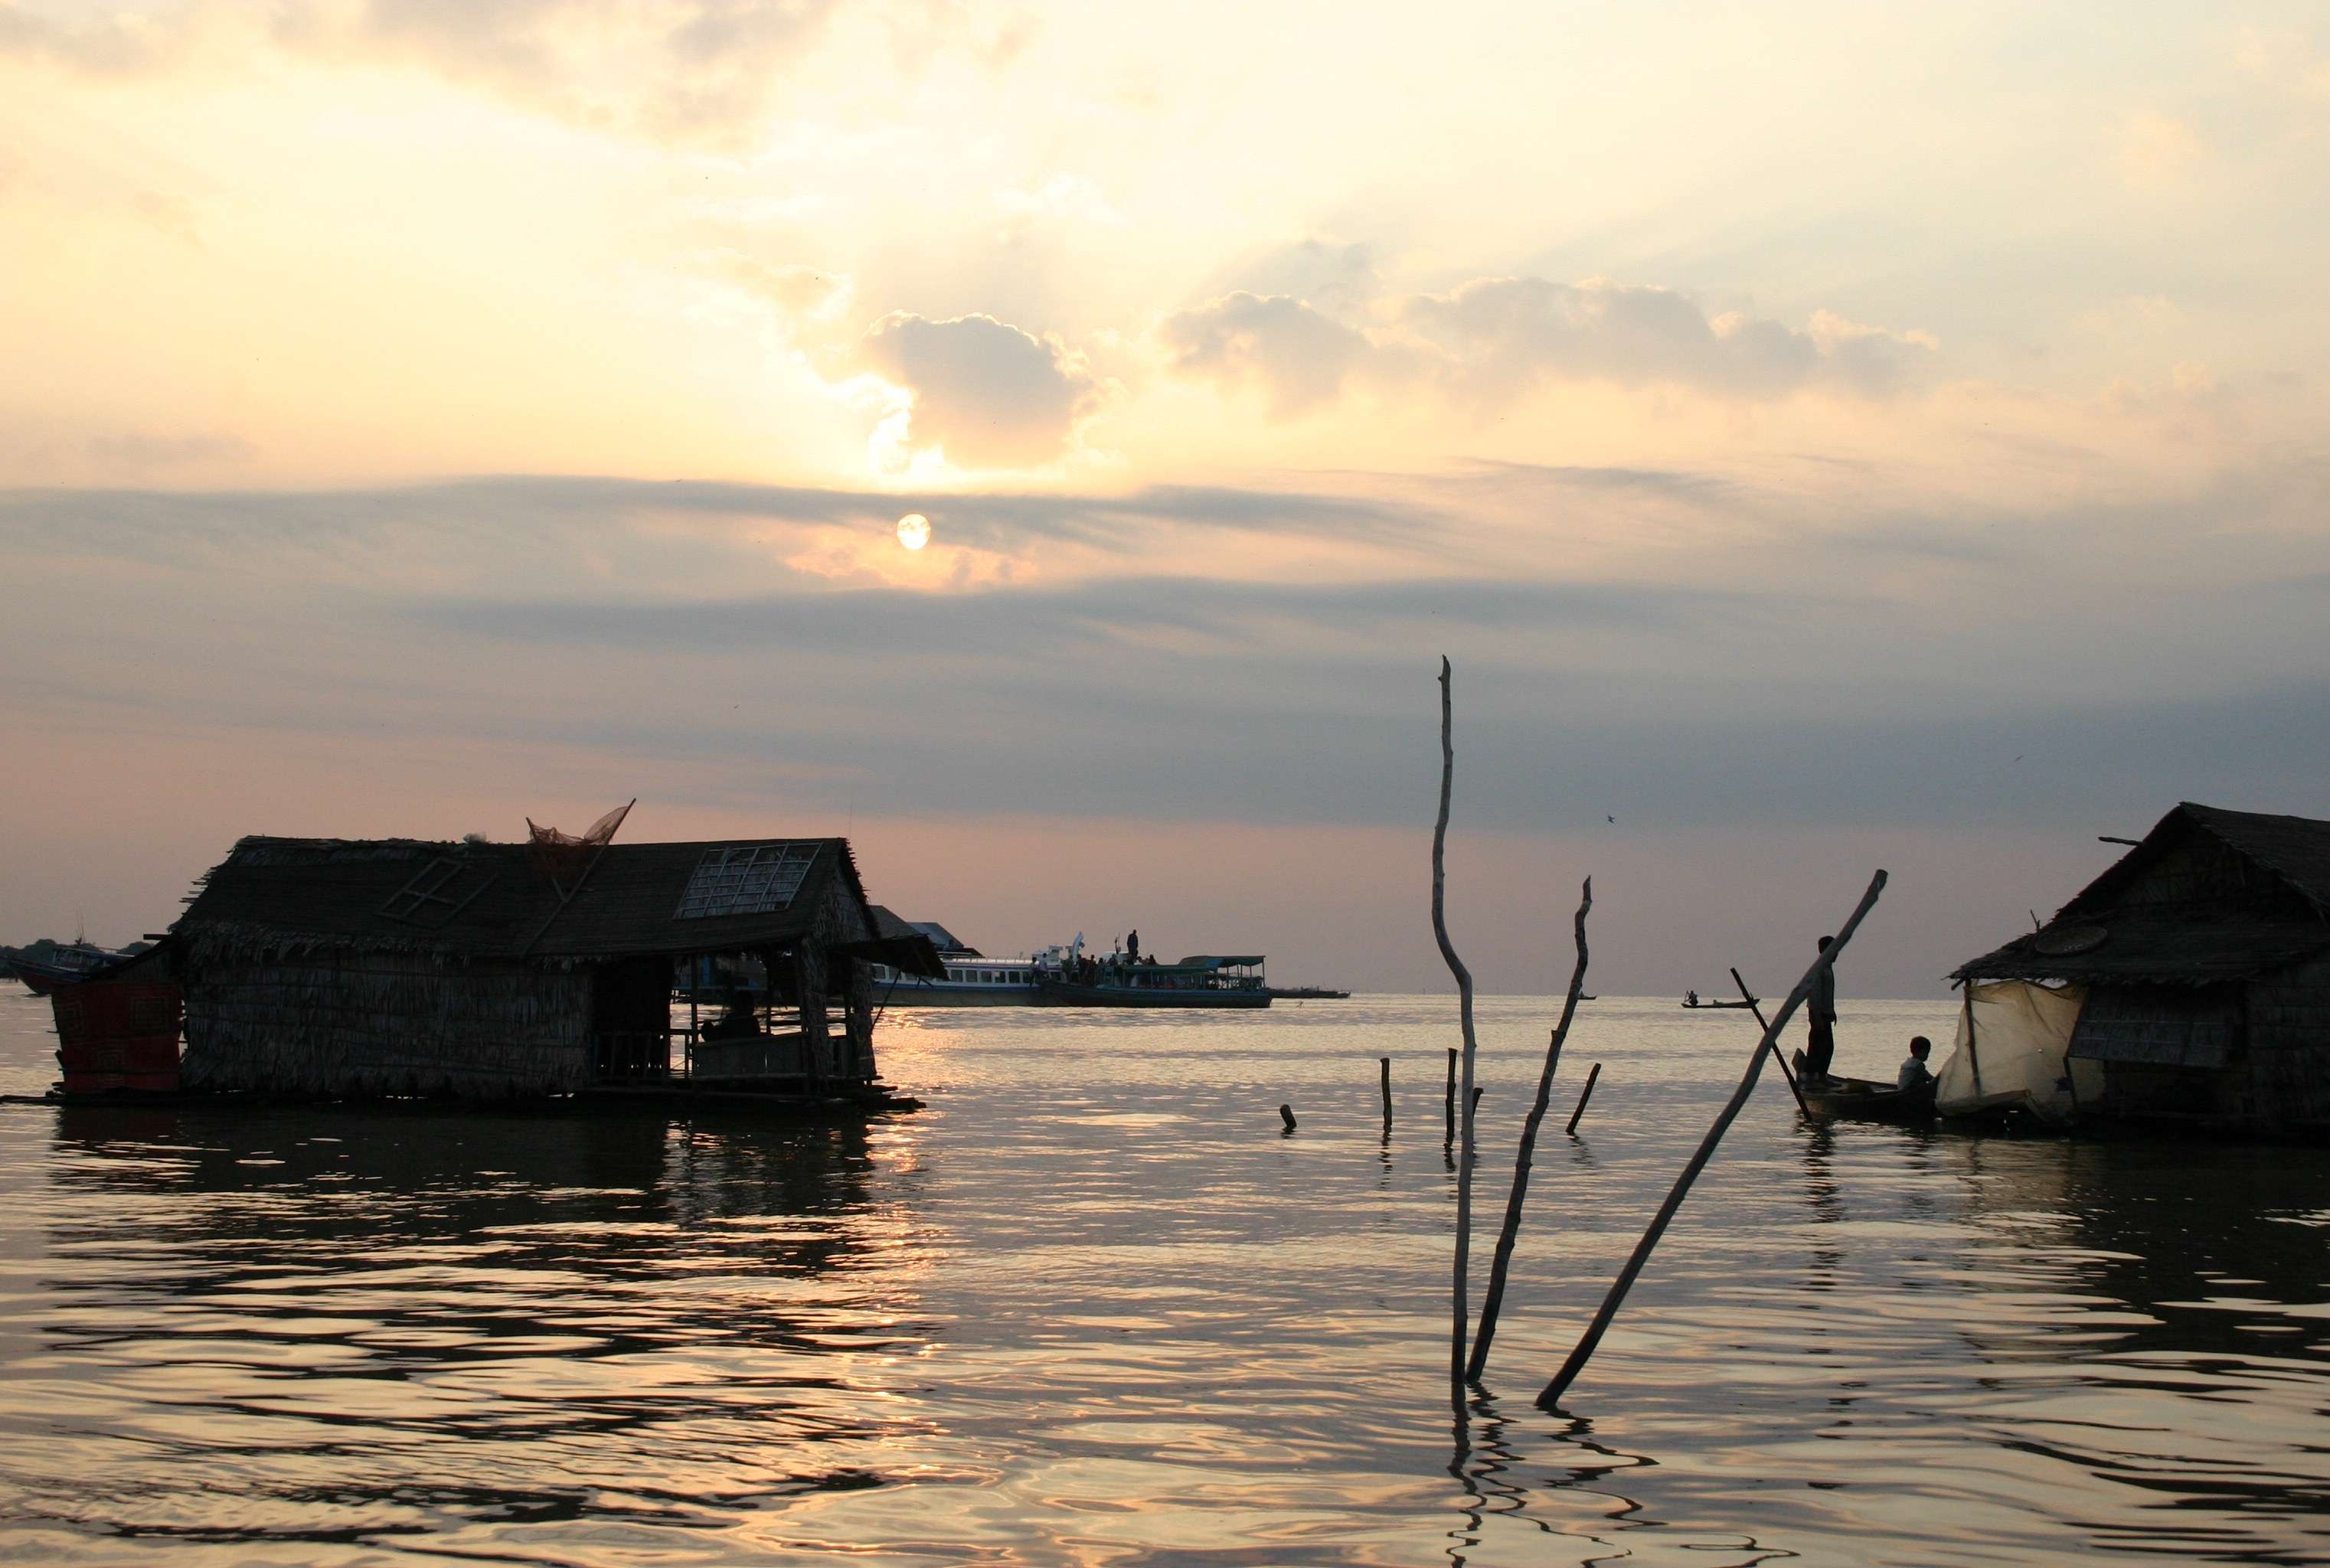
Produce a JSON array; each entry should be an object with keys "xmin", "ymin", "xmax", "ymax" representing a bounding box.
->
[{"xmin": 0, "ymin": 0, "xmax": 2330, "ymax": 997}]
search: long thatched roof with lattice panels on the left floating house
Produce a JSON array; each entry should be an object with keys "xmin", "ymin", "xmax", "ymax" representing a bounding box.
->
[{"xmin": 170, "ymin": 839, "xmax": 946, "ymax": 960}]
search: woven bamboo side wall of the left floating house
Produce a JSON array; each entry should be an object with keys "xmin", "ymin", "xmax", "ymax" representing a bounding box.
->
[{"xmin": 184, "ymin": 953, "xmax": 592, "ymax": 1095}]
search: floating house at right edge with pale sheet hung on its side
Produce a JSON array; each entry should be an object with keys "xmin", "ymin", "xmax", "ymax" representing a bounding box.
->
[{"xmin": 1936, "ymin": 802, "xmax": 2330, "ymax": 1132}]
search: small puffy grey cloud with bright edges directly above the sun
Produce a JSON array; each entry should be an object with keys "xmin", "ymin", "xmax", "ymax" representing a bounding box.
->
[{"xmin": 858, "ymin": 310, "xmax": 1102, "ymax": 469}]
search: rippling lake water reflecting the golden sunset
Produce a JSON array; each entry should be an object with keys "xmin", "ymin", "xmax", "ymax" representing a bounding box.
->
[{"xmin": 0, "ymin": 985, "xmax": 2330, "ymax": 1568}]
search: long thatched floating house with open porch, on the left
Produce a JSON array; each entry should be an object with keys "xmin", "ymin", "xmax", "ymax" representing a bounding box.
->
[{"xmin": 93, "ymin": 839, "xmax": 936, "ymax": 1097}]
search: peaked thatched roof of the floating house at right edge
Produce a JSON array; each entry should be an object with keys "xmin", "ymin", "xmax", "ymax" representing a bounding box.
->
[{"xmin": 1950, "ymin": 802, "xmax": 2330, "ymax": 985}]
